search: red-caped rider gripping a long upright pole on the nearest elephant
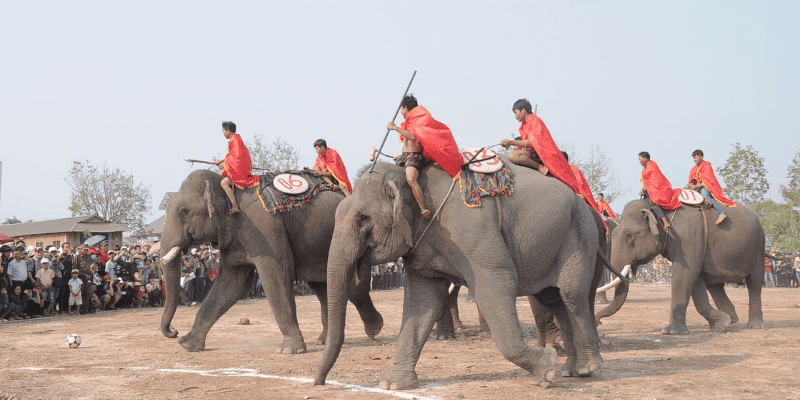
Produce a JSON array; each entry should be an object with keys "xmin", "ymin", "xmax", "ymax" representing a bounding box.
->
[{"xmin": 386, "ymin": 94, "xmax": 464, "ymax": 218}]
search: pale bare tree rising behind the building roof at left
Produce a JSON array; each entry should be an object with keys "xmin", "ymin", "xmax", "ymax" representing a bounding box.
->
[{"xmin": 64, "ymin": 160, "xmax": 152, "ymax": 230}]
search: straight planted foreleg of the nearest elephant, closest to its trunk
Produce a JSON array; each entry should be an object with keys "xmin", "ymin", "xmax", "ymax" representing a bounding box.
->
[{"xmin": 380, "ymin": 269, "xmax": 450, "ymax": 390}]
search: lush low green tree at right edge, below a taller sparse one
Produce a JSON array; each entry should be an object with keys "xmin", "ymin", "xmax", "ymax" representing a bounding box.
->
[{"xmin": 751, "ymin": 200, "xmax": 800, "ymax": 251}]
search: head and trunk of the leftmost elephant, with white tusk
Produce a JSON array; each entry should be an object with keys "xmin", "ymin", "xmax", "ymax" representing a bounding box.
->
[{"xmin": 161, "ymin": 170, "xmax": 232, "ymax": 338}]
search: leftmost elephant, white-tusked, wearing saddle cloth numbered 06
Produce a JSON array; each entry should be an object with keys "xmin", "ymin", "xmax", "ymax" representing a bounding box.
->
[{"xmin": 161, "ymin": 170, "xmax": 383, "ymax": 354}]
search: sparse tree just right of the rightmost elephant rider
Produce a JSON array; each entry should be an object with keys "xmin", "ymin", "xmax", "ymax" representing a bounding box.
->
[{"xmin": 719, "ymin": 143, "xmax": 769, "ymax": 206}]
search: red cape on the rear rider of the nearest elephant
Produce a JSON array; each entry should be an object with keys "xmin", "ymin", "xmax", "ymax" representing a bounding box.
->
[{"xmin": 519, "ymin": 114, "xmax": 581, "ymax": 193}]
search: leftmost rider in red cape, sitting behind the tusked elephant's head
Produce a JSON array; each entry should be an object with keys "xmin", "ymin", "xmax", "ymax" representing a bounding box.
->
[{"xmin": 217, "ymin": 121, "xmax": 258, "ymax": 215}]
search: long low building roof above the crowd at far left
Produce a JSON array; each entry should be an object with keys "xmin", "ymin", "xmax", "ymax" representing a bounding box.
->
[{"xmin": 0, "ymin": 215, "xmax": 131, "ymax": 237}]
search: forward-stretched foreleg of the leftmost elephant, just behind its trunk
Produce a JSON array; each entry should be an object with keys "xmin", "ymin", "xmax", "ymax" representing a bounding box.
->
[{"xmin": 178, "ymin": 265, "xmax": 253, "ymax": 351}]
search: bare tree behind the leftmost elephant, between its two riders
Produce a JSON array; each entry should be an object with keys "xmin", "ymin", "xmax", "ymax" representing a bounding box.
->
[{"xmin": 208, "ymin": 133, "xmax": 300, "ymax": 175}]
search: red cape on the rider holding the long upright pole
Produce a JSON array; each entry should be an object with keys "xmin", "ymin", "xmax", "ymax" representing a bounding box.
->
[{"xmin": 400, "ymin": 106, "xmax": 464, "ymax": 178}]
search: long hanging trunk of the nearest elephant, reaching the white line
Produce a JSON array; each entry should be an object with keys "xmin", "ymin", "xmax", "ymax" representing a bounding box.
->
[{"xmin": 314, "ymin": 238, "xmax": 358, "ymax": 385}]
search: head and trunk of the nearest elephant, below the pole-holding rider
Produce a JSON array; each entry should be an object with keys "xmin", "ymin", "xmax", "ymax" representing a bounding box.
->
[{"xmin": 315, "ymin": 163, "xmax": 424, "ymax": 384}]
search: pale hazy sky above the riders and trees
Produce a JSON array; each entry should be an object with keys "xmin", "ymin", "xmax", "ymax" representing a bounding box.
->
[{"xmin": 0, "ymin": 0, "xmax": 800, "ymax": 220}]
